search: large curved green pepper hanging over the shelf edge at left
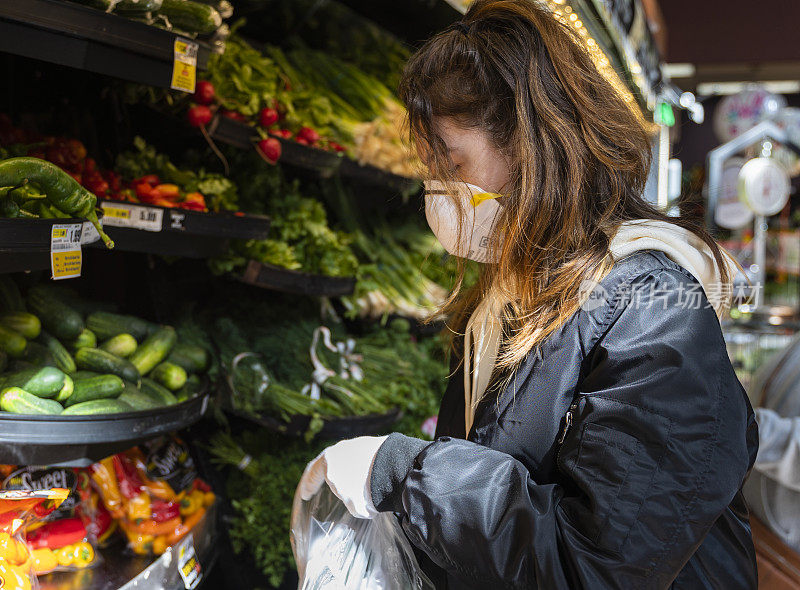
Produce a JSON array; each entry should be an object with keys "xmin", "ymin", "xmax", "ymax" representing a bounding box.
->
[{"xmin": 0, "ymin": 158, "xmax": 114, "ymax": 248}]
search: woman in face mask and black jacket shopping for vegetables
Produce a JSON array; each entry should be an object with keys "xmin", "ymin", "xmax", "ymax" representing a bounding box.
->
[{"xmin": 299, "ymin": 0, "xmax": 757, "ymax": 590}]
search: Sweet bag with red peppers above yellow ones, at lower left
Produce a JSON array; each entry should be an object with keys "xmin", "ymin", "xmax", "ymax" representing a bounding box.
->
[{"xmin": 0, "ymin": 465, "xmax": 113, "ymax": 575}]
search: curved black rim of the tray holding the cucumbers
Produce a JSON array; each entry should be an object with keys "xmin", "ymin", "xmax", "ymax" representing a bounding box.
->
[{"xmin": 0, "ymin": 394, "xmax": 209, "ymax": 467}]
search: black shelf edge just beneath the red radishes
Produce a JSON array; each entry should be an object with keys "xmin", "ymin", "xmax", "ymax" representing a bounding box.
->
[{"xmin": 208, "ymin": 115, "xmax": 420, "ymax": 192}]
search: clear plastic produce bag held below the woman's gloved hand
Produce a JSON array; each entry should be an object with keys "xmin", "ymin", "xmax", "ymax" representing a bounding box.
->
[{"xmin": 291, "ymin": 485, "xmax": 434, "ymax": 590}]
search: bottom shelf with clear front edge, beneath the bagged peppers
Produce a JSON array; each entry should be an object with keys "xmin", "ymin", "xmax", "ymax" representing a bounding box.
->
[{"xmin": 39, "ymin": 504, "xmax": 218, "ymax": 590}]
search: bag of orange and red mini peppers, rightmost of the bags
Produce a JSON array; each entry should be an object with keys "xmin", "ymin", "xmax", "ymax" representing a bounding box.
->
[{"xmin": 91, "ymin": 437, "xmax": 215, "ymax": 555}]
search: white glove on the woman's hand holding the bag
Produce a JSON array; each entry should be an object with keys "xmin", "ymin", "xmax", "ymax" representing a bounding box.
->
[{"xmin": 297, "ymin": 436, "xmax": 386, "ymax": 518}]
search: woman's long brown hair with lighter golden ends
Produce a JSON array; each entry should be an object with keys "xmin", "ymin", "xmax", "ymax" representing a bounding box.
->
[{"xmin": 400, "ymin": 0, "xmax": 727, "ymax": 368}]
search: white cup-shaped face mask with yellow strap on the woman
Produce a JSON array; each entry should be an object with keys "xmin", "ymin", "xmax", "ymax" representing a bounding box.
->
[{"xmin": 425, "ymin": 180, "xmax": 501, "ymax": 262}]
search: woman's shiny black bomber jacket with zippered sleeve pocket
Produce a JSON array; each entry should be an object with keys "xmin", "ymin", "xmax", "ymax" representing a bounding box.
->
[{"xmin": 370, "ymin": 251, "xmax": 758, "ymax": 590}]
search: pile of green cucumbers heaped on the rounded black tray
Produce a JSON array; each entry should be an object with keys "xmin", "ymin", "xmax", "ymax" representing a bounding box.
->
[{"xmin": 0, "ymin": 276, "xmax": 209, "ymax": 416}]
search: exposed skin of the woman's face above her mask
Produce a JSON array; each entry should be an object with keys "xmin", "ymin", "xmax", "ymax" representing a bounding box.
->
[{"xmin": 434, "ymin": 118, "xmax": 510, "ymax": 194}]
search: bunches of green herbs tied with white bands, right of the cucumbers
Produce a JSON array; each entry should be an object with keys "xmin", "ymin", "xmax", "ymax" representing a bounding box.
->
[{"xmin": 202, "ymin": 291, "xmax": 447, "ymax": 439}]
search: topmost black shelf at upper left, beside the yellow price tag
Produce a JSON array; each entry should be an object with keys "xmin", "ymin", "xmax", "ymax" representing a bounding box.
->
[{"xmin": 0, "ymin": 0, "xmax": 211, "ymax": 88}]
